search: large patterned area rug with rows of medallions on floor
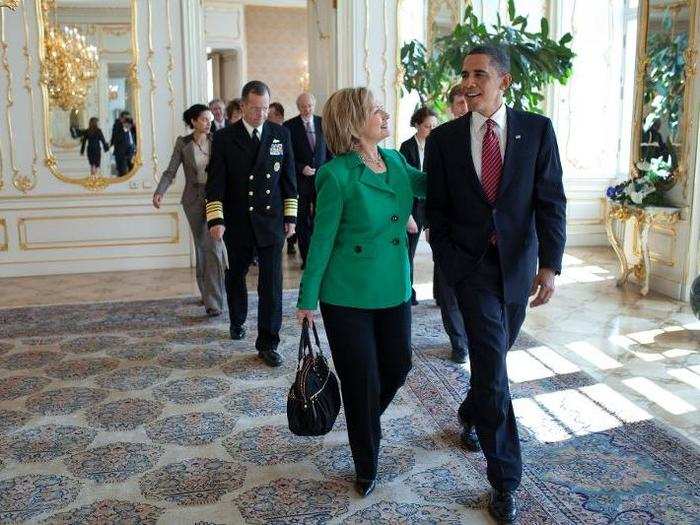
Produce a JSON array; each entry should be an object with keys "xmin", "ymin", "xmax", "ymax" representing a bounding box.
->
[{"xmin": 0, "ymin": 293, "xmax": 700, "ymax": 525}]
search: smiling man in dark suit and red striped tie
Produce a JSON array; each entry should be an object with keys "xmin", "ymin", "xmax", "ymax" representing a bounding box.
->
[{"xmin": 425, "ymin": 46, "xmax": 566, "ymax": 523}]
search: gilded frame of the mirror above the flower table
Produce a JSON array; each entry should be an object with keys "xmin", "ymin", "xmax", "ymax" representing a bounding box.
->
[{"xmin": 630, "ymin": 0, "xmax": 697, "ymax": 190}]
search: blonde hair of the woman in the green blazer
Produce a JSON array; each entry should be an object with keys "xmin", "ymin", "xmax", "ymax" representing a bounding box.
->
[{"xmin": 323, "ymin": 87, "xmax": 374, "ymax": 155}]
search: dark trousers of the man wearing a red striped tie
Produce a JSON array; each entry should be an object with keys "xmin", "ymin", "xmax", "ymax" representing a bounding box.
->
[{"xmin": 455, "ymin": 246, "xmax": 525, "ymax": 490}]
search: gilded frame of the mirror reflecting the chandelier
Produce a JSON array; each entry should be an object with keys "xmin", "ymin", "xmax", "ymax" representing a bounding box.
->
[{"xmin": 35, "ymin": 0, "xmax": 143, "ymax": 191}]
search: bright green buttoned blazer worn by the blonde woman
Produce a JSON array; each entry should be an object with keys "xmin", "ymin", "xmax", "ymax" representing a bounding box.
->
[{"xmin": 297, "ymin": 148, "xmax": 426, "ymax": 310}]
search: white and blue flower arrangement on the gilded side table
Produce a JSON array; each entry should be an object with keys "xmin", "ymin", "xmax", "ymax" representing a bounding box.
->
[{"xmin": 606, "ymin": 157, "xmax": 673, "ymax": 207}]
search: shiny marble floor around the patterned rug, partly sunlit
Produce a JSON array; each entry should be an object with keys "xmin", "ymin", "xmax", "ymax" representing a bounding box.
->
[{"xmin": 0, "ymin": 243, "xmax": 700, "ymax": 446}]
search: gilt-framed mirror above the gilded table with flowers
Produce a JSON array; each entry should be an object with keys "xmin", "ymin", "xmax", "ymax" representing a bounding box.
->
[{"xmin": 631, "ymin": 0, "xmax": 696, "ymax": 189}]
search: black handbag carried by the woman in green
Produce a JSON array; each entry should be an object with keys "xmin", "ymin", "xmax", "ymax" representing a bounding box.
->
[{"xmin": 287, "ymin": 320, "xmax": 340, "ymax": 436}]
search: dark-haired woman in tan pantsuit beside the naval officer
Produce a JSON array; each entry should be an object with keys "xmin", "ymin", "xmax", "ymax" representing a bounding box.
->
[{"xmin": 153, "ymin": 104, "xmax": 226, "ymax": 317}]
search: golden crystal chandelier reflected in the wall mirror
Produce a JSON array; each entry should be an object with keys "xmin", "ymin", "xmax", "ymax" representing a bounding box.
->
[{"xmin": 42, "ymin": 0, "xmax": 100, "ymax": 111}]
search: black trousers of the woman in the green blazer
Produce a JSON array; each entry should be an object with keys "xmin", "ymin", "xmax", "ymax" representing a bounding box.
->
[{"xmin": 321, "ymin": 302, "xmax": 411, "ymax": 480}]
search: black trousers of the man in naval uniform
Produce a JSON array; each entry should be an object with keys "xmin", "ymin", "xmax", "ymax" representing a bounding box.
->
[{"xmin": 226, "ymin": 241, "xmax": 284, "ymax": 350}]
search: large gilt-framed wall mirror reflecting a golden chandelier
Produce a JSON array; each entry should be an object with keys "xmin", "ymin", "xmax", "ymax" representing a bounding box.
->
[{"xmin": 36, "ymin": 0, "xmax": 141, "ymax": 190}]
